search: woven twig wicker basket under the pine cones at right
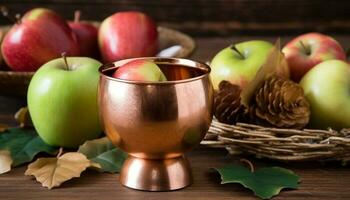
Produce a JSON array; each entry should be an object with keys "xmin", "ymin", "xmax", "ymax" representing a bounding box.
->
[{"xmin": 201, "ymin": 120, "xmax": 350, "ymax": 163}]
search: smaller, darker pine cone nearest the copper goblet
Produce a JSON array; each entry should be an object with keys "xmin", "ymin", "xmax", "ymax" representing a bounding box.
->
[{"xmin": 214, "ymin": 81, "xmax": 246, "ymax": 124}]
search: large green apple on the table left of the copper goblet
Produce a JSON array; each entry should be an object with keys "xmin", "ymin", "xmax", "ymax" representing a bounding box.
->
[{"xmin": 27, "ymin": 57, "xmax": 102, "ymax": 148}]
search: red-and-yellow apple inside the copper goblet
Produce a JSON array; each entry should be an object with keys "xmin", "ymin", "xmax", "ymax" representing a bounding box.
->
[{"xmin": 113, "ymin": 59, "xmax": 167, "ymax": 81}]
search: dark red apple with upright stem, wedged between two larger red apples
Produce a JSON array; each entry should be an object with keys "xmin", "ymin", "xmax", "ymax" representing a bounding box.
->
[{"xmin": 68, "ymin": 10, "xmax": 98, "ymax": 58}]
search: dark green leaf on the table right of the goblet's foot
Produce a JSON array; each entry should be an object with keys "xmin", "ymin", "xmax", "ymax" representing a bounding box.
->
[{"xmin": 216, "ymin": 164, "xmax": 300, "ymax": 199}]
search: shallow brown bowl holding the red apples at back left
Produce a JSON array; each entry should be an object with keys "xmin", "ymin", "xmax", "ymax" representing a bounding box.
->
[{"xmin": 0, "ymin": 25, "xmax": 195, "ymax": 97}]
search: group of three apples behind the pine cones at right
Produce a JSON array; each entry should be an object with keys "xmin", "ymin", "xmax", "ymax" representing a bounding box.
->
[{"xmin": 210, "ymin": 33, "xmax": 350, "ymax": 129}]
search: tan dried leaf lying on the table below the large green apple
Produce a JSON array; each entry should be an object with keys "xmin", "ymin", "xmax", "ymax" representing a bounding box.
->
[{"xmin": 25, "ymin": 152, "xmax": 91, "ymax": 189}]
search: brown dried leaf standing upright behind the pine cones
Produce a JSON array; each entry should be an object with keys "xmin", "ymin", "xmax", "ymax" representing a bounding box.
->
[{"xmin": 241, "ymin": 38, "xmax": 289, "ymax": 107}]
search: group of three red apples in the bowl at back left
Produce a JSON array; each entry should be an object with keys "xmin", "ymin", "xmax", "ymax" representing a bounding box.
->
[{"xmin": 1, "ymin": 8, "xmax": 158, "ymax": 71}]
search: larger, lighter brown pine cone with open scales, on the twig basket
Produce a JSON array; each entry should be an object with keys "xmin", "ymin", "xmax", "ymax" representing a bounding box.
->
[{"xmin": 249, "ymin": 76, "xmax": 310, "ymax": 129}]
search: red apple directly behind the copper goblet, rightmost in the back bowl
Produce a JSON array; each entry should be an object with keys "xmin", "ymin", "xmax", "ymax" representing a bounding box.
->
[{"xmin": 98, "ymin": 11, "xmax": 158, "ymax": 62}]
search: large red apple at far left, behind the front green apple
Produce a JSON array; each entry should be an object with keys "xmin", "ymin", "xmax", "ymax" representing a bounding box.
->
[{"xmin": 1, "ymin": 8, "xmax": 79, "ymax": 71}]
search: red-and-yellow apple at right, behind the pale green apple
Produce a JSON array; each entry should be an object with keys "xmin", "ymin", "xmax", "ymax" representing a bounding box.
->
[{"xmin": 282, "ymin": 33, "xmax": 346, "ymax": 82}]
